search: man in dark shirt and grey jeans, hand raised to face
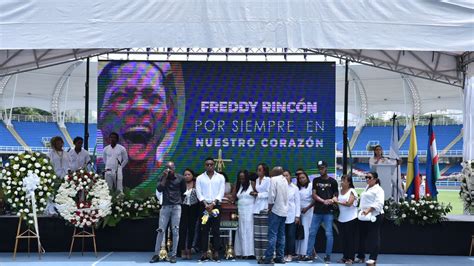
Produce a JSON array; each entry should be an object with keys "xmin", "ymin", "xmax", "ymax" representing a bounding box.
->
[{"xmin": 150, "ymin": 162, "xmax": 186, "ymax": 263}]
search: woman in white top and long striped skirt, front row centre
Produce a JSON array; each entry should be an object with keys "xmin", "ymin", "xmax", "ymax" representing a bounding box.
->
[{"xmin": 250, "ymin": 163, "xmax": 270, "ymax": 260}]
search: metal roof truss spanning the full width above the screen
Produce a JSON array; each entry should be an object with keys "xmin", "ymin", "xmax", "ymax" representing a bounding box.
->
[{"xmin": 0, "ymin": 47, "xmax": 474, "ymax": 87}]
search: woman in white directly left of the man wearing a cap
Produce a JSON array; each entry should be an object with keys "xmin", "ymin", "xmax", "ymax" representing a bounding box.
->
[{"xmin": 296, "ymin": 172, "xmax": 314, "ymax": 258}]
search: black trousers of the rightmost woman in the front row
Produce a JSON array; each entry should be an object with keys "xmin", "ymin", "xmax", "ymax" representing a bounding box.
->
[{"xmin": 357, "ymin": 214, "xmax": 383, "ymax": 260}]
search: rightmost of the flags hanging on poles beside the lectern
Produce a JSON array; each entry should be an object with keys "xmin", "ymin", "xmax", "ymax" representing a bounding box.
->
[{"xmin": 425, "ymin": 120, "xmax": 440, "ymax": 199}]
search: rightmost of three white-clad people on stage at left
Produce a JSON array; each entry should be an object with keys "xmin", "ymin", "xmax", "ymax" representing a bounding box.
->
[{"xmin": 104, "ymin": 132, "xmax": 128, "ymax": 193}]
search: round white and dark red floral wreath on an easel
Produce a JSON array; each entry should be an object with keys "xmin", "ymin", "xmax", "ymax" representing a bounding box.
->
[{"xmin": 55, "ymin": 170, "xmax": 112, "ymax": 228}]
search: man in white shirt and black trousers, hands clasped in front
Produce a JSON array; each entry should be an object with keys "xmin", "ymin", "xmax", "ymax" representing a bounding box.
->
[{"xmin": 196, "ymin": 157, "xmax": 225, "ymax": 261}]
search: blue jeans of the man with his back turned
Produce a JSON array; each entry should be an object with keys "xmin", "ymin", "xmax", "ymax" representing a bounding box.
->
[{"xmin": 265, "ymin": 212, "xmax": 286, "ymax": 262}]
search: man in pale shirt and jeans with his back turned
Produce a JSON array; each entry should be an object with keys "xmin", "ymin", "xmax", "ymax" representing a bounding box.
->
[{"xmin": 259, "ymin": 166, "xmax": 288, "ymax": 264}]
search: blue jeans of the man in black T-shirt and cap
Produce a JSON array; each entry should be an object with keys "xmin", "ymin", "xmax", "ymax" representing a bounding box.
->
[{"xmin": 306, "ymin": 213, "xmax": 334, "ymax": 257}]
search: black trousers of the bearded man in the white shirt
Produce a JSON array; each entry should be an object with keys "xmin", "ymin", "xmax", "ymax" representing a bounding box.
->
[{"xmin": 199, "ymin": 204, "xmax": 222, "ymax": 252}]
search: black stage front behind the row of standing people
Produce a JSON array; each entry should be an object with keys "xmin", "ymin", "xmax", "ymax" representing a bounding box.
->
[{"xmin": 0, "ymin": 216, "xmax": 474, "ymax": 256}]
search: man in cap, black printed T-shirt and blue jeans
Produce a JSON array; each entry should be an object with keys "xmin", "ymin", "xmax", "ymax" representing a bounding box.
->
[{"xmin": 304, "ymin": 161, "xmax": 338, "ymax": 263}]
